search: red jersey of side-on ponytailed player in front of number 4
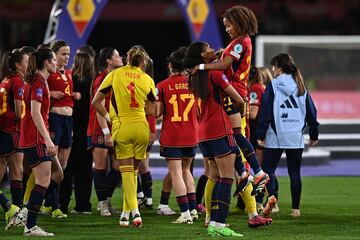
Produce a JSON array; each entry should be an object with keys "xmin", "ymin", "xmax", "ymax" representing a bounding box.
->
[{"xmin": 19, "ymin": 74, "xmax": 50, "ymax": 148}]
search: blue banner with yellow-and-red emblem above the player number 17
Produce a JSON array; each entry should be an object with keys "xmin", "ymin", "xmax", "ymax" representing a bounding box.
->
[{"xmin": 176, "ymin": 0, "xmax": 223, "ymax": 50}]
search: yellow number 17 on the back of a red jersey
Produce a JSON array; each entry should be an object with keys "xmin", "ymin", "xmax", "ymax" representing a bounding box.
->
[{"xmin": 169, "ymin": 93, "xmax": 195, "ymax": 122}]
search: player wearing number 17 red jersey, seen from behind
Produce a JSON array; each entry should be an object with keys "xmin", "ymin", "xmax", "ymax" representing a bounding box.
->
[{"xmin": 156, "ymin": 47, "xmax": 199, "ymax": 223}]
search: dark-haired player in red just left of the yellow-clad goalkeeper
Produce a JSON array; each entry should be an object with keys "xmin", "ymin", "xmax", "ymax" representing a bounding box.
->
[{"xmin": 87, "ymin": 48, "xmax": 123, "ymax": 216}]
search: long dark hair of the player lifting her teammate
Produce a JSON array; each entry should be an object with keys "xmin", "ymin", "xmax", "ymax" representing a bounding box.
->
[{"xmin": 184, "ymin": 42, "xmax": 209, "ymax": 100}]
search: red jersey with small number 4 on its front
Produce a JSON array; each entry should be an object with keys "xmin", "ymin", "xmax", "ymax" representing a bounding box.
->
[{"xmin": 47, "ymin": 70, "xmax": 74, "ymax": 107}]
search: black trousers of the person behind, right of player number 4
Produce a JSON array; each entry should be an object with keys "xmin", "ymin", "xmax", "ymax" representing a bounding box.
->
[{"xmin": 59, "ymin": 126, "xmax": 92, "ymax": 212}]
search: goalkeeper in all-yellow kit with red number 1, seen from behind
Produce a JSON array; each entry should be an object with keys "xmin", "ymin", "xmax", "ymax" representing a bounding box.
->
[{"xmin": 92, "ymin": 46, "xmax": 156, "ymax": 227}]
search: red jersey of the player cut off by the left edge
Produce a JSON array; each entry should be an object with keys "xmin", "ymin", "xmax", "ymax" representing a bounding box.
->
[{"xmin": 0, "ymin": 74, "xmax": 24, "ymax": 132}]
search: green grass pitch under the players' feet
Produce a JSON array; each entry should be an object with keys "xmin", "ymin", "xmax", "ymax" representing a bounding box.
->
[{"xmin": 0, "ymin": 177, "xmax": 360, "ymax": 240}]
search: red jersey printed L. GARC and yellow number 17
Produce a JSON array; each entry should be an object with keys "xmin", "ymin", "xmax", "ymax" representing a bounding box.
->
[{"xmin": 156, "ymin": 75, "xmax": 199, "ymax": 147}]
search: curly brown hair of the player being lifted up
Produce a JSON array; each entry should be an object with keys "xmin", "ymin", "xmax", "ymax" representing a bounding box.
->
[{"xmin": 223, "ymin": 6, "xmax": 258, "ymax": 36}]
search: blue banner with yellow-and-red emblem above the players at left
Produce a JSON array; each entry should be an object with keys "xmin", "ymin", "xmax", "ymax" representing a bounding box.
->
[{"xmin": 56, "ymin": 0, "xmax": 107, "ymax": 68}]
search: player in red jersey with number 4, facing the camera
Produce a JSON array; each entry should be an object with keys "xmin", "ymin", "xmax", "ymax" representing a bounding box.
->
[{"xmin": 42, "ymin": 40, "xmax": 81, "ymax": 218}]
